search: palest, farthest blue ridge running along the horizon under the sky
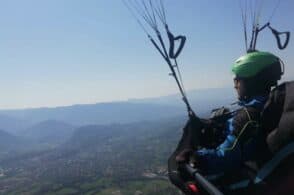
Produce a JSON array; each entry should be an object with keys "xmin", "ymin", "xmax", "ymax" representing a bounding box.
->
[{"xmin": 0, "ymin": 88, "xmax": 235, "ymax": 127}]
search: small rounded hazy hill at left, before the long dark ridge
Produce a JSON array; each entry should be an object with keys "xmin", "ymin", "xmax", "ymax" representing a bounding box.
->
[{"xmin": 21, "ymin": 120, "xmax": 75, "ymax": 145}]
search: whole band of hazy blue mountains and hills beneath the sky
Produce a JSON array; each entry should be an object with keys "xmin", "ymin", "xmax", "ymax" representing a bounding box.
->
[{"xmin": 0, "ymin": 89, "xmax": 233, "ymax": 161}]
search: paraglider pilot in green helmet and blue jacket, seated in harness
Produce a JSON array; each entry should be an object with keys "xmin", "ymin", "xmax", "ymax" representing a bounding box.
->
[{"xmin": 168, "ymin": 51, "xmax": 283, "ymax": 194}]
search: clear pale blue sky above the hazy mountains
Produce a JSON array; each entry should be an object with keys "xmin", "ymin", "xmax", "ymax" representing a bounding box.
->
[{"xmin": 0, "ymin": 0, "xmax": 294, "ymax": 109}]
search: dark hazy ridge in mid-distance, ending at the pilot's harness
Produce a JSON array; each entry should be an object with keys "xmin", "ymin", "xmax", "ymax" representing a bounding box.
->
[{"xmin": 67, "ymin": 117, "xmax": 187, "ymax": 148}]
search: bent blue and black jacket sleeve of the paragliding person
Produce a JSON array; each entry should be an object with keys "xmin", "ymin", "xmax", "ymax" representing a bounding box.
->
[{"xmin": 196, "ymin": 108, "xmax": 259, "ymax": 174}]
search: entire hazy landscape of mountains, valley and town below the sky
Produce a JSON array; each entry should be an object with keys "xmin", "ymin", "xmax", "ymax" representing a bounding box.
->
[{"xmin": 0, "ymin": 90, "xmax": 233, "ymax": 195}]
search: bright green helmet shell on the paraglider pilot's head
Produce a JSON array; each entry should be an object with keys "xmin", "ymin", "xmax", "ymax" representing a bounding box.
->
[{"xmin": 232, "ymin": 51, "xmax": 282, "ymax": 78}]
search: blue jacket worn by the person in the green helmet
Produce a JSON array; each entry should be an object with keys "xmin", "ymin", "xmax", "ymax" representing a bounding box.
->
[{"xmin": 196, "ymin": 96, "xmax": 267, "ymax": 174}]
